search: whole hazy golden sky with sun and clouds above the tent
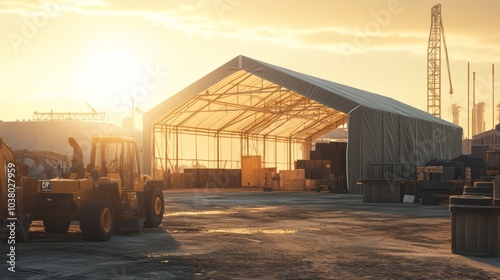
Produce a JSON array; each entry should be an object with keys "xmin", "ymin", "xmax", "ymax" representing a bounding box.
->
[{"xmin": 0, "ymin": 0, "xmax": 500, "ymax": 137}]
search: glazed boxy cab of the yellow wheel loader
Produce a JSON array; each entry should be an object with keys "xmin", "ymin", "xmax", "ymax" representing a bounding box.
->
[{"xmin": 87, "ymin": 136, "xmax": 143, "ymax": 191}]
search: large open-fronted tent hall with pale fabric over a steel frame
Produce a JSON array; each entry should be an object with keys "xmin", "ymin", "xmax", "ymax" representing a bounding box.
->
[{"xmin": 144, "ymin": 56, "xmax": 462, "ymax": 190}]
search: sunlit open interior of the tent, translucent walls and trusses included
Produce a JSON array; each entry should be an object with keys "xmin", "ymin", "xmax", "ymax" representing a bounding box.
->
[{"xmin": 149, "ymin": 70, "xmax": 347, "ymax": 176}]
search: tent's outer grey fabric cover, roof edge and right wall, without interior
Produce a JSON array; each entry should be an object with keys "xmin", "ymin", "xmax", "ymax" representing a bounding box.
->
[{"xmin": 144, "ymin": 56, "xmax": 462, "ymax": 187}]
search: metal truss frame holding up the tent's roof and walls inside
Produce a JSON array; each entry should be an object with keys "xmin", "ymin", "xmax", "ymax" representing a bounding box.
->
[{"xmin": 153, "ymin": 70, "xmax": 347, "ymax": 175}]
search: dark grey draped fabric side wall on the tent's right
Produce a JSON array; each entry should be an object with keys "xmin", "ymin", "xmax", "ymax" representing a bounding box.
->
[{"xmin": 347, "ymin": 106, "xmax": 462, "ymax": 193}]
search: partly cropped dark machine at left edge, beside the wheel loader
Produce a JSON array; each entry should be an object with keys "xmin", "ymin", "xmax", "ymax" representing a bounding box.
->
[{"xmin": 0, "ymin": 138, "xmax": 30, "ymax": 242}]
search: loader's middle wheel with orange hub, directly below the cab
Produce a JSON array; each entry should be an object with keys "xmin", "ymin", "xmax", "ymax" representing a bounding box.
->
[{"xmin": 80, "ymin": 200, "xmax": 115, "ymax": 241}]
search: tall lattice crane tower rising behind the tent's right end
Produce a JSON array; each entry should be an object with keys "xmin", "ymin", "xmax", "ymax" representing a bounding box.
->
[{"xmin": 427, "ymin": 4, "xmax": 453, "ymax": 118}]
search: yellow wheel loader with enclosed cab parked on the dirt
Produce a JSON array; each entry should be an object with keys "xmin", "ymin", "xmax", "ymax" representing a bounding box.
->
[{"xmin": 30, "ymin": 136, "xmax": 165, "ymax": 241}]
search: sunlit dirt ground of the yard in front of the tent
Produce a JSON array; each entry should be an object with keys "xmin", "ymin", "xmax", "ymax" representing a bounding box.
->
[{"xmin": 0, "ymin": 189, "xmax": 500, "ymax": 279}]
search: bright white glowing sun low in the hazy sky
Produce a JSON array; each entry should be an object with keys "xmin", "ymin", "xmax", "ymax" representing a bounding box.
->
[{"xmin": 84, "ymin": 50, "xmax": 143, "ymax": 98}]
